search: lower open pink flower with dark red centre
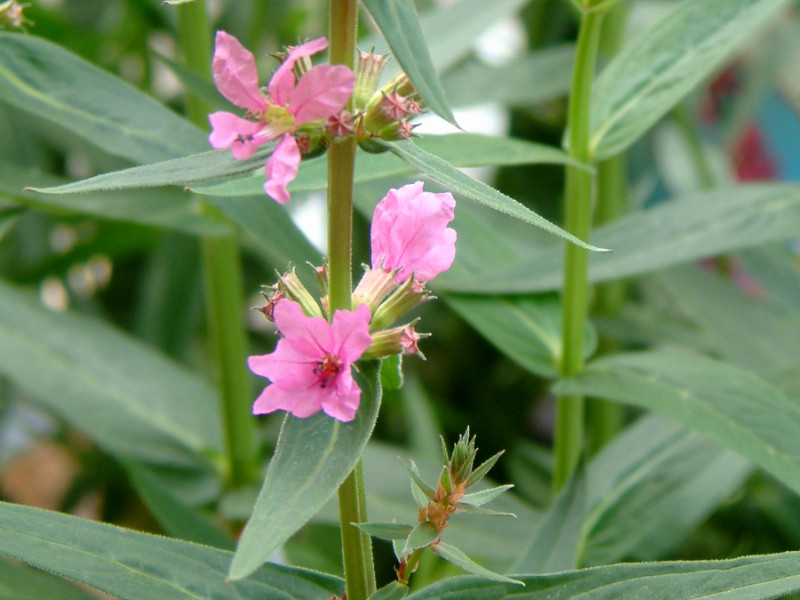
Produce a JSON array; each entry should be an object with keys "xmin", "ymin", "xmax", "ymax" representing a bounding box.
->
[{"xmin": 248, "ymin": 300, "xmax": 372, "ymax": 422}]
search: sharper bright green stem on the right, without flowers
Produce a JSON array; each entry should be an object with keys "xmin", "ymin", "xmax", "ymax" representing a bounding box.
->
[{"xmin": 553, "ymin": 5, "xmax": 602, "ymax": 490}]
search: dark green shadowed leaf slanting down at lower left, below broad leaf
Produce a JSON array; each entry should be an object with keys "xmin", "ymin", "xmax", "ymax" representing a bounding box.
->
[{"xmin": 125, "ymin": 462, "xmax": 236, "ymax": 550}]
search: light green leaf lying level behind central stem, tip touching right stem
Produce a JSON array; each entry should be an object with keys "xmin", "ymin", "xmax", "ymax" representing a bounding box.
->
[{"xmin": 194, "ymin": 133, "xmax": 579, "ymax": 197}]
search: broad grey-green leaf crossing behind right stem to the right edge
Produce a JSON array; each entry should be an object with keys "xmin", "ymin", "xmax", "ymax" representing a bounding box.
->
[{"xmin": 436, "ymin": 184, "xmax": 800, "ymax": 294}]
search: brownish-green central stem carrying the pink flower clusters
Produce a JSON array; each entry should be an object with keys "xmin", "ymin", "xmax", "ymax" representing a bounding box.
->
[{"xmin": 328, "ymin": 0, "xmax": 376, "ymax": 600}]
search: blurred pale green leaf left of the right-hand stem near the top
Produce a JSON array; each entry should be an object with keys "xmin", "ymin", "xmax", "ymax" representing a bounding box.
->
[{"xmin": 442, "ymin": 45, "xmax": 575, "ymax": 106}]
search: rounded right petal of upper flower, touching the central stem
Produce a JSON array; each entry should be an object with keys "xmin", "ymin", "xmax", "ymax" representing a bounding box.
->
[{"xmin": 288, "ymin": 65, "xmax": 355, "ymax": 124}]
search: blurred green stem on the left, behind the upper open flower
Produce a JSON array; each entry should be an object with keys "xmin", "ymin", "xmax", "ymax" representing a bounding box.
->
[{"xmin": 178, "ymin": 1, "xmax": 255, "ymax": 487}]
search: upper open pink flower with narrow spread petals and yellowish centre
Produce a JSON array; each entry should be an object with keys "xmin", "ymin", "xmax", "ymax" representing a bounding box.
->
[{"xmin": 208, "ymin": 31, "xmax": 355, "ymax": 204}]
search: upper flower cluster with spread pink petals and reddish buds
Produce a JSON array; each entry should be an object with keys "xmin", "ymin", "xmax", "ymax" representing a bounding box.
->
[{"xmin": 209, "ymin": 33, "xmax": 422, "ymax": 204}]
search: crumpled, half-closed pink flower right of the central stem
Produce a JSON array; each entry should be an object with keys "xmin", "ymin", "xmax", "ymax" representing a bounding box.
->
[{"xmin": 370, "ymin": 181, "xmax": 456, "ymax": 282}]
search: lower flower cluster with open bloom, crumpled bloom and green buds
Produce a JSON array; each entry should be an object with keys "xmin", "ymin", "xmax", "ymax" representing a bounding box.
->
[{"xmin": 249, "ymin": 182, "xmax": 456, "ymax": 421}]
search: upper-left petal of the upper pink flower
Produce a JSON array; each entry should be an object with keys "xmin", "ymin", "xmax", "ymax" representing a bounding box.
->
[{"xmin": 211, "ymin": 31, "xmax": 267, "ymax": 114}]
